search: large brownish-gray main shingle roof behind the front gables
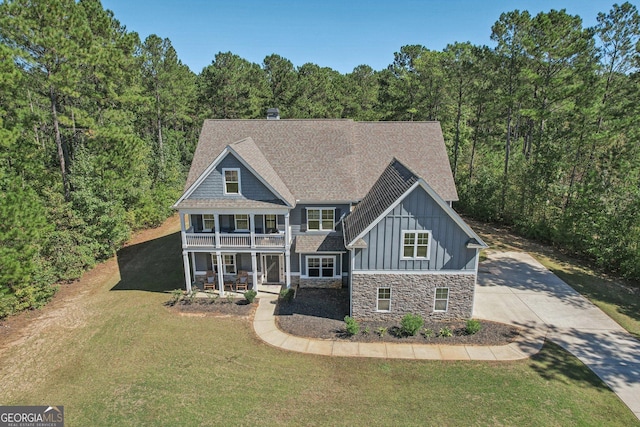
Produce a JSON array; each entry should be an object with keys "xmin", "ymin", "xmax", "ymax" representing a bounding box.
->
[{"xmin": 185, "ymin": 120, "xmax": 458, "ymax": 201}]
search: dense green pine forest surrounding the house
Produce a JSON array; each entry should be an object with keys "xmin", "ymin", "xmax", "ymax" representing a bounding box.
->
[{"xmin": 0, "ymin": 0, "xmax": 640, "ymax": 317}]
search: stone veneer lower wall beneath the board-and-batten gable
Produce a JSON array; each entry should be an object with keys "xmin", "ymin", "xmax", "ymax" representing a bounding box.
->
[{"xmin": 351, "ymin": 273, "xmax": 476, "ymax": 321}]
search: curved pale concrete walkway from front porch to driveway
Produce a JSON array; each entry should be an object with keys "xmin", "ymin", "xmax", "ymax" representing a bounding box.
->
[{"xmin": 253, "ymin": 295, "xmax": 546, "ymax": 361}]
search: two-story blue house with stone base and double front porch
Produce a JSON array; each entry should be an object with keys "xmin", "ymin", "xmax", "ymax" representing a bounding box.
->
[{"xmin": 174, "ymin": 115, "xmax": 486, "ymax": 319}]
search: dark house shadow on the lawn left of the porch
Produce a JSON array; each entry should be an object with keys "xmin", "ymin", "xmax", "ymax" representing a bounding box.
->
[{"xmin": 111, "ymin": 232, "xmax": 184, "ymax": 292}]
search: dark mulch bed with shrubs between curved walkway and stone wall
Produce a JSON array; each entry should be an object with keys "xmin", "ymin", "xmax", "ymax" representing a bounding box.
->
[{"xmin": 275, "ymin": 288, "xmax": 520, "ymax": 345}]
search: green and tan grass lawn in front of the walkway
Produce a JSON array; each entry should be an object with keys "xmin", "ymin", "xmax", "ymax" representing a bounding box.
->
[{"xmin": 0, "ymin": 219, "xmax": 640, "ymax": 426}]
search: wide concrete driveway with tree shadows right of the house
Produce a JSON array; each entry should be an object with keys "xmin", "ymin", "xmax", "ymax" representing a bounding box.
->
[{"xmin": 474, "ymin": 252, "xmax": 640, "ymax": 419}]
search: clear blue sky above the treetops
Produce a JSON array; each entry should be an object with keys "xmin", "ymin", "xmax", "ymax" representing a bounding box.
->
[{"xmin": 102, "ymin": 0, "xmax": 637, "ymax": 73}]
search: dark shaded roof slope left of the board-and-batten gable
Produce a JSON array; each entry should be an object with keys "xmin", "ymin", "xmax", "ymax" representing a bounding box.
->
[{"xmin": 344, "ymin": 159, "xmax": 419, "ymax": 245}]
